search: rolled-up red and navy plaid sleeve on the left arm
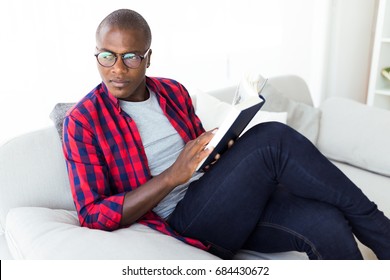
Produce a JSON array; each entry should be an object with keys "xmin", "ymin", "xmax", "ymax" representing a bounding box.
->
[{"xmin": 63, "ymin": 116, "xmax": 125, "ymax": 231}]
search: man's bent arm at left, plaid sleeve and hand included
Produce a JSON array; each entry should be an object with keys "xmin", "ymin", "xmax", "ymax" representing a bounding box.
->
[{"xmin": 63, "ymin": 114, "xmax": 213, "ymax": 230}]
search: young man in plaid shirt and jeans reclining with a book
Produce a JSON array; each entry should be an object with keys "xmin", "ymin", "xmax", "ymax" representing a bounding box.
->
[{"xmin": 63, "ymin": 10, "xmax": 390, "ymax": 259}]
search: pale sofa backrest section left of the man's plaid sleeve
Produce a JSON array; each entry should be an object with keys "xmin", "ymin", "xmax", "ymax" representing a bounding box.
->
[{"xmin": 0, "ymin": 126, "xmax": 75, "ymax": 228}]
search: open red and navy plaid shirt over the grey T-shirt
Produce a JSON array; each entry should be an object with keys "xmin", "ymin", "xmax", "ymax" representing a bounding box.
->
[{"xmin": 63, "ymin": 77, "xmax": 206, "ymax": 249}]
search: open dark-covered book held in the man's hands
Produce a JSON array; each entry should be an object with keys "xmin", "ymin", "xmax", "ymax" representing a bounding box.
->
[{"xmin": 197, "ymin": 76, "xmax": 267, "ymax": 171}]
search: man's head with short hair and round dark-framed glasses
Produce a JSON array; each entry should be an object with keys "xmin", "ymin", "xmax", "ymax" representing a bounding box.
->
[{"xmin": 96, "ymin": 9, "xmax": 152, "ymax": 101}]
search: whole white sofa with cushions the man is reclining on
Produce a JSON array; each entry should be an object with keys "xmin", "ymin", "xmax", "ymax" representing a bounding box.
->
[{"xmin": 0, "ymin": 76, "xmax": 390, "ymax": 259}]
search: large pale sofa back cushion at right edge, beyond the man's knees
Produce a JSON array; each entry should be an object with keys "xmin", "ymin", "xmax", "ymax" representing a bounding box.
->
[{"xmin": 318, "ymin": 97, "xmax": 390, "ymax": 176}]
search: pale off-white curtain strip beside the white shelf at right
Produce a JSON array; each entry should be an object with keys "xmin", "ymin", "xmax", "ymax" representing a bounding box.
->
[{"xmin": 322, "ymin": 0, "xmax": 378, "ymax": 103}]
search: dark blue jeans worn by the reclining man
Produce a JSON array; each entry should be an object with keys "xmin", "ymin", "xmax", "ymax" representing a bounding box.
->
[{"xmin": 168, "ymin": 123, "xmax": 390, "ymax": 259}]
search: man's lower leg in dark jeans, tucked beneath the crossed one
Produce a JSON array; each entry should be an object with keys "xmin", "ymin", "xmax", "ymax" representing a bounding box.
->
[{"xmin": 243, "ymin": 187, "xmax": 363, "ymax": 260}]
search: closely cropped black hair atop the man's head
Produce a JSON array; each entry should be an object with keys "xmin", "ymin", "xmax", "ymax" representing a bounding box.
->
[{"xmin": 96, "ymin": 9, "xmax": 152, "ymax": 47}]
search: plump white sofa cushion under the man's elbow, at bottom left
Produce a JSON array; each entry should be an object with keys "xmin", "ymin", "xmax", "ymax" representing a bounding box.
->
[{"xmin": 5, "ymin": 207, "xmax": 217, "ymax": 260}]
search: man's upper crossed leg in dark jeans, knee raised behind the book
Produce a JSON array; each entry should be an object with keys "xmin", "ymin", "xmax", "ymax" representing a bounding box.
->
[{"xmin": 169, "ymin": 123, "xmax": 390, "ymax": 258}]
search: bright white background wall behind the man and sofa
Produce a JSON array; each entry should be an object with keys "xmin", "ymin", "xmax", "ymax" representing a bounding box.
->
[{"xmin": 0, "ymin": 0, "xmax": 371, "ymax": 143}]
